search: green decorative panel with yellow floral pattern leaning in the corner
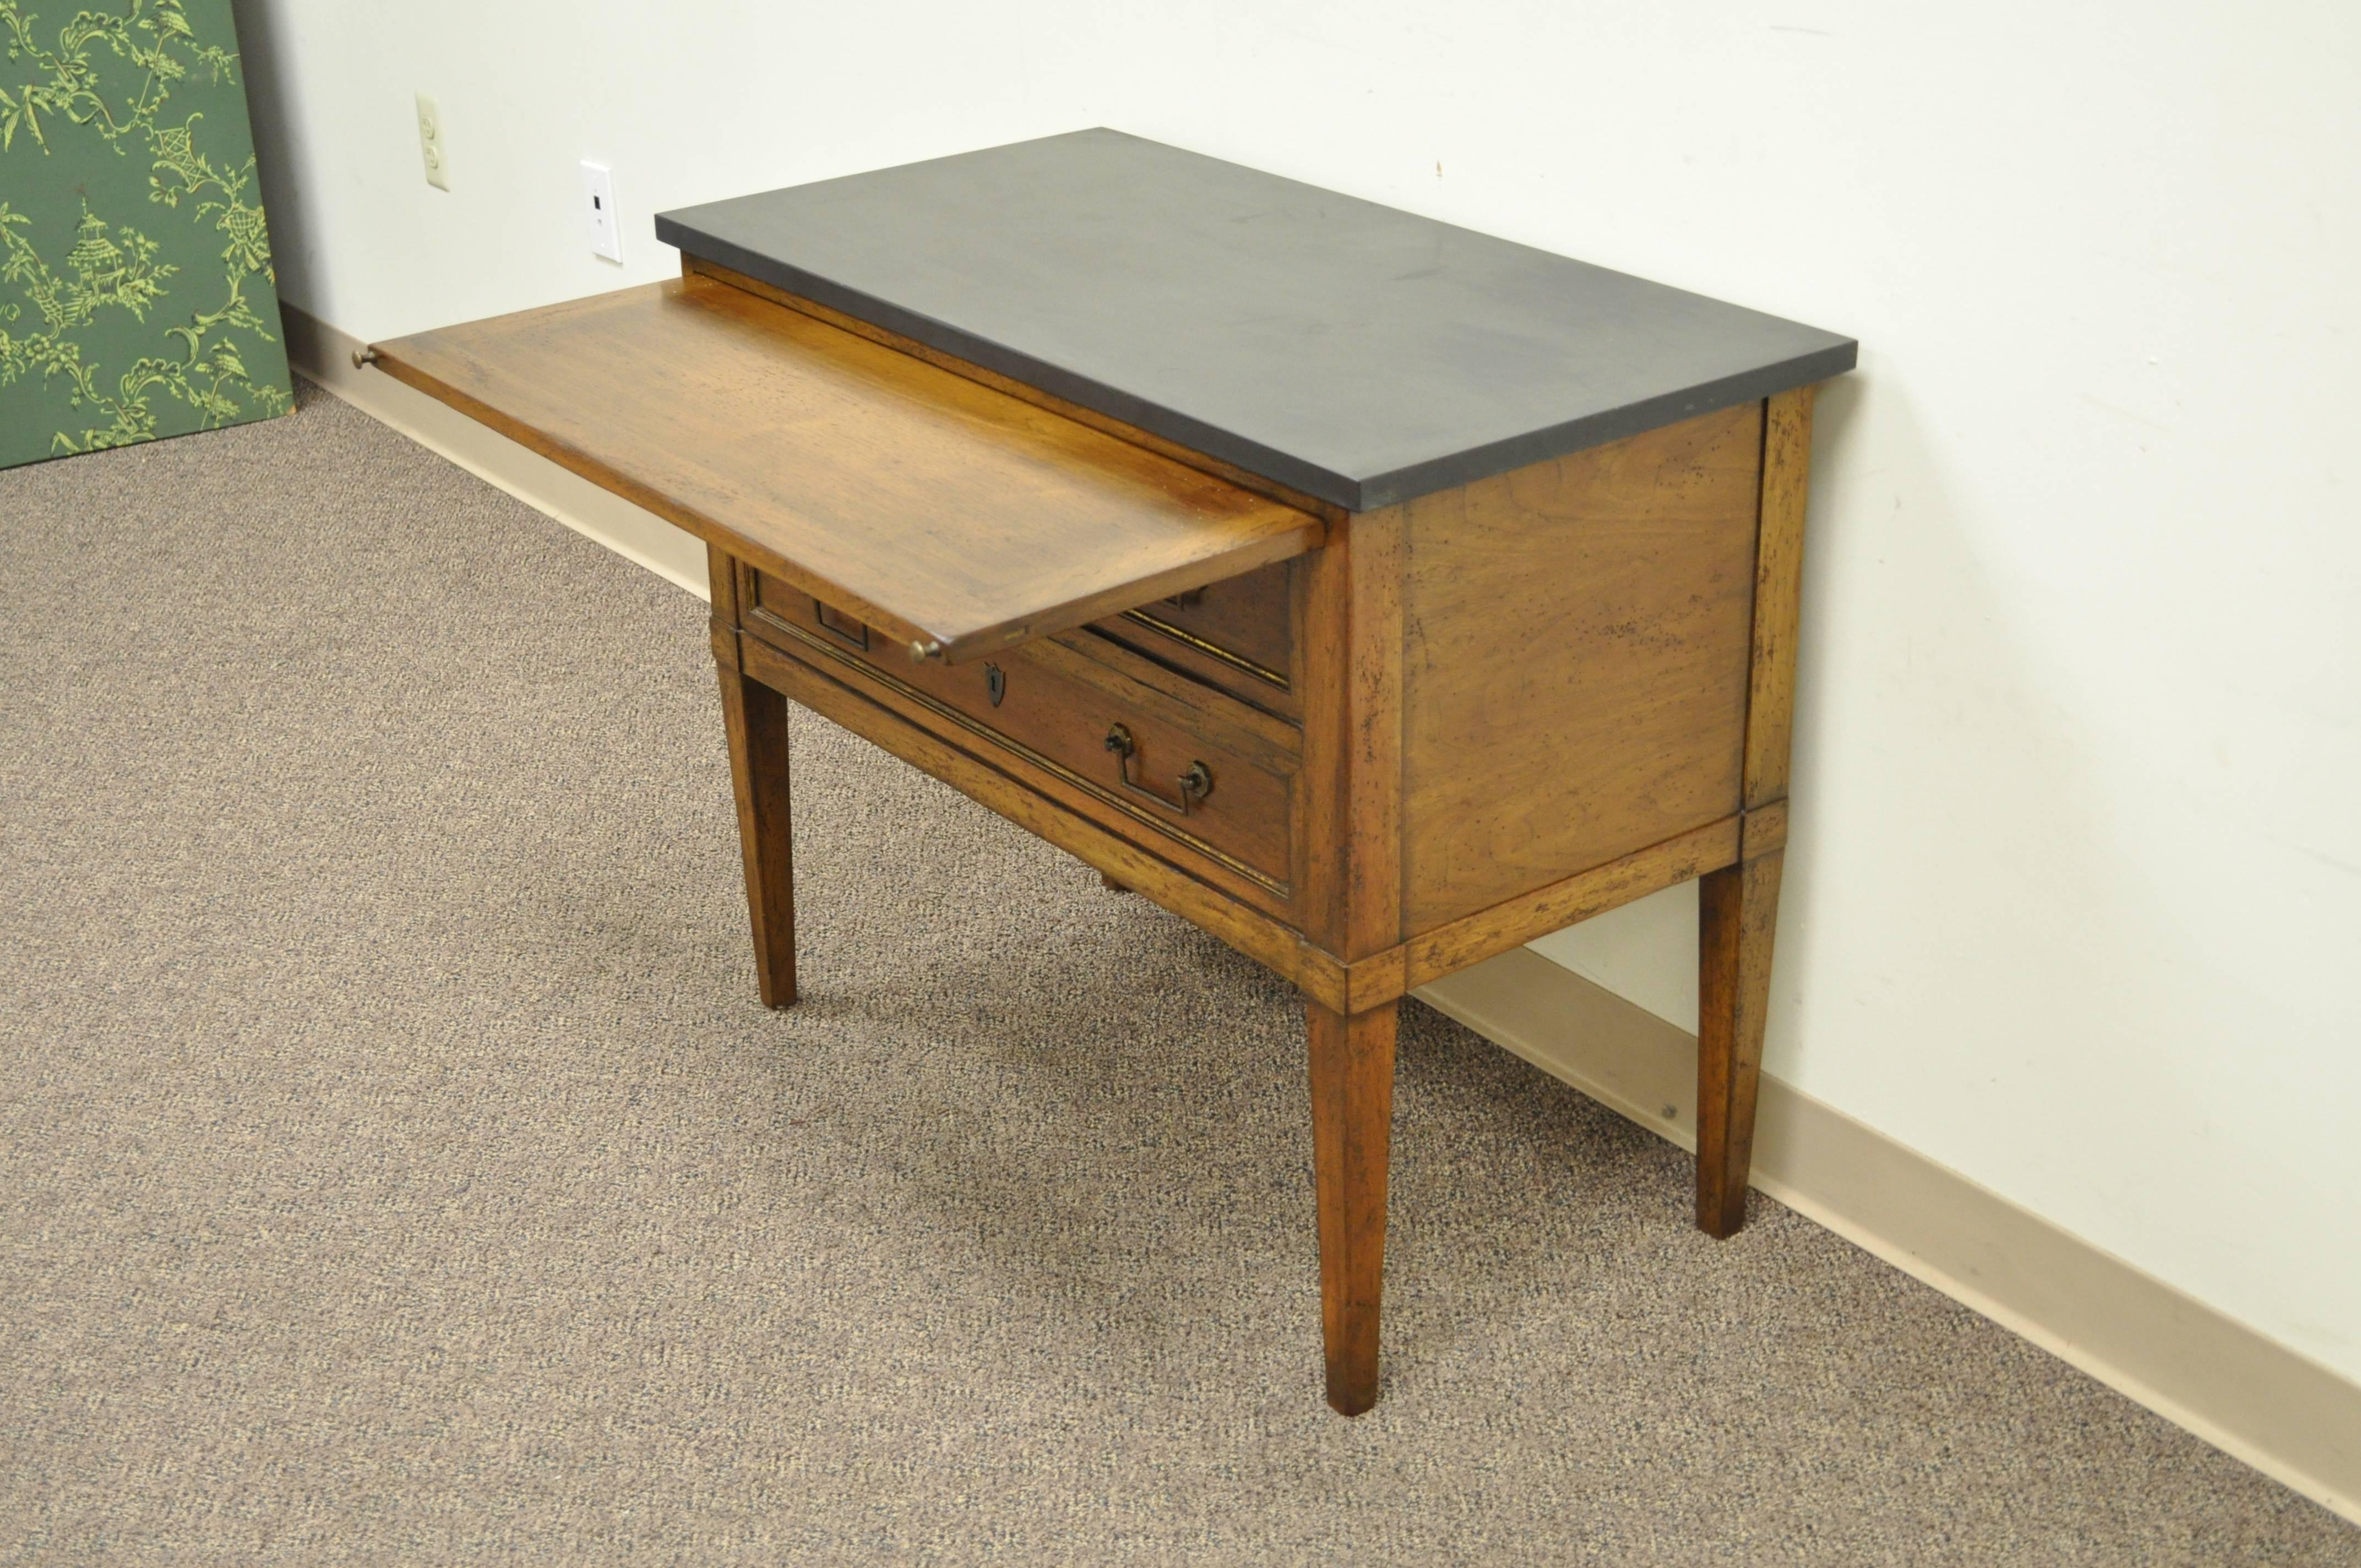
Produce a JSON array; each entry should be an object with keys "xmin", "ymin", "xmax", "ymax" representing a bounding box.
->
[{"xmin": 0, "ymin": 0, "xmax": 293, "ymax": 467}]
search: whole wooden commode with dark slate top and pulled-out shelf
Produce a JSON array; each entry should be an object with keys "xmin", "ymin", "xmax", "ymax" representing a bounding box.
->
[{"xmin": 371, "ymin": 130, "xmax": 1853, "ymax": 1414}]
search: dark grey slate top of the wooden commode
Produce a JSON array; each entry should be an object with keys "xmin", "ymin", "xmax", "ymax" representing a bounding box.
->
[{"xmin": 656, "ymin": 130, "xmax": 1856, "ymax": 510}]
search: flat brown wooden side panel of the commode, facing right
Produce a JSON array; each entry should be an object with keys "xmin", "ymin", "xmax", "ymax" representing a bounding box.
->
[{"xmin": 1402, "ymin": 404, "xmax": 1761, "ymax": 930}]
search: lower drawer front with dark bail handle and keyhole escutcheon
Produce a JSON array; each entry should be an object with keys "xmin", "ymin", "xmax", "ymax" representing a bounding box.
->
[{"xmin": 746, "ymin": 574, "xmax": 1298, "ymax": 900}]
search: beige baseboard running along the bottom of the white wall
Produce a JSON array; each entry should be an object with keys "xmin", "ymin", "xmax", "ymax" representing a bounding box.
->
[{"xmin": 281, "ymin": 304, "xmax": 2361, "ymax": 1523}]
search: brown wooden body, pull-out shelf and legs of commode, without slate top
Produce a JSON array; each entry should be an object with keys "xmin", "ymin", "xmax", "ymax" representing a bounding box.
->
[{"xmin": 380, "ymin": 221, "xmax": 1841, "ymax": 1414}]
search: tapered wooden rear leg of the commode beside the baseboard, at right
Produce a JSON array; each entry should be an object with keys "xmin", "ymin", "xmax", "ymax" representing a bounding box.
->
[{"xmin": 1698, "ymin": 850, "xmax": 1782, "ymax": 1238}]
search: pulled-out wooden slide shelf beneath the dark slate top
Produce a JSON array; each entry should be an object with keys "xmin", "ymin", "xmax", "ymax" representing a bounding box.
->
[{"xmin": 378, "ymin": 279, "xmax": 1322, "ymax": 663}]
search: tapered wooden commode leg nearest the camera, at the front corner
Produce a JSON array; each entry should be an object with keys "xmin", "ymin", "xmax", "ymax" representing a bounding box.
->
[{"xmin": 1303, "ymin": 1001, "xmax": 1395, "ymax": 1414}]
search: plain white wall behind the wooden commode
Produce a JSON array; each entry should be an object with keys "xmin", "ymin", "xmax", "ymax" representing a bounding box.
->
[{"xmin": 238, "ymin": 0, "xmax": 2361, "ymax": 1379}]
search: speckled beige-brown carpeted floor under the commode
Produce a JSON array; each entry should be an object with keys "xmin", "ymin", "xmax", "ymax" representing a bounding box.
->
[{"xmin": 0, "ymin": 382, "xmax": 2361, "ymax": 1566}]
